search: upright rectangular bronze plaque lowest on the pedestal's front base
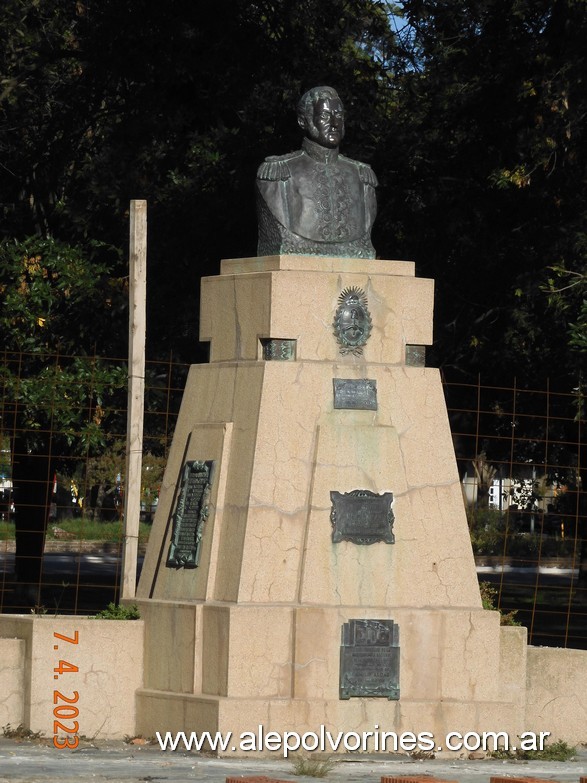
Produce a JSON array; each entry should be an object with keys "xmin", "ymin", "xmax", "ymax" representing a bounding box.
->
[{"xmin": 339, "ymin": 620, "xmax": 399, "ymax": 699}]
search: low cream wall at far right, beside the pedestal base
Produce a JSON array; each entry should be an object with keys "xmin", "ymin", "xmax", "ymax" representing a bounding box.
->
[{"xmin": 525, "ymin": 647, "xmax": 587, "ymax": 744}]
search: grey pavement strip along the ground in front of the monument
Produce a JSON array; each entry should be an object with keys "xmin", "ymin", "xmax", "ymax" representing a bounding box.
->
[{"xmin": 0, "ymin": 738, "xmax": 587, "ymax": 783}]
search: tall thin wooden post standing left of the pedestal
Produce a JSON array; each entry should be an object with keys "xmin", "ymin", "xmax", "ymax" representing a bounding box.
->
[{"xmin": 121, "ymin": 200, "xmax": 147, "ymax": 598}]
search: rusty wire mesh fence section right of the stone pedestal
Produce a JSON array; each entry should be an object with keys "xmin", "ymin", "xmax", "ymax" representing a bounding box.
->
[{"xmin": 445, "ymin": 379, "xmax": 587, "ymax": 649}]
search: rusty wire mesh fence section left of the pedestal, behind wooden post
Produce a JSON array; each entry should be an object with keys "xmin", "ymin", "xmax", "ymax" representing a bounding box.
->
[{"xmin": 0, "ymin": 351, "xmax": 188, "ymax": 614}]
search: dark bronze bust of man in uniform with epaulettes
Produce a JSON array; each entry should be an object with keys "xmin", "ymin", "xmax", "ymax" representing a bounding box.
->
[{"xmin": 257, "ymin": 87, "xmax": 377, "ymax": 258}]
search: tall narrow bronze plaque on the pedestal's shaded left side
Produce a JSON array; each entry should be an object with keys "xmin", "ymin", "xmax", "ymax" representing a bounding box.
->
[{"xmin": 167, "ymin": 460, "xmax": 214, "ymax": 568}]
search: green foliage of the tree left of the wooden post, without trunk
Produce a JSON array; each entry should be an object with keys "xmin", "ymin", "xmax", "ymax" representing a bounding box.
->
[{"xmin": 0, "ymin": 238, "xmax": 126, "ymax": 454}]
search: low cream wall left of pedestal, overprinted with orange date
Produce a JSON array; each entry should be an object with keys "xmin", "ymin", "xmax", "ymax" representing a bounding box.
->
[{"xmin": 0, "ymin": 615, "xmax": 144, "ymax": 740}]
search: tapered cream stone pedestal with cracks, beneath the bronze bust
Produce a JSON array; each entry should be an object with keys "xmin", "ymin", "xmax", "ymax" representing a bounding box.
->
[{"xmin": 138, "ymin": 256, "xmax": 525, "ymax": 753}]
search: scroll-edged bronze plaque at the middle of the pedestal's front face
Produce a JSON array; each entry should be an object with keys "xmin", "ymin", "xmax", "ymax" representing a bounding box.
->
[{"xmin": 330, "ymin": 489, "xmax": 395, "ymax": 544}]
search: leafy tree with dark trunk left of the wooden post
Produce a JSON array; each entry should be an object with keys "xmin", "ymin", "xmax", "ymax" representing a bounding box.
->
[{"xmin": 0, "ymin": 238, "xmax": 126, "ymax": 603}]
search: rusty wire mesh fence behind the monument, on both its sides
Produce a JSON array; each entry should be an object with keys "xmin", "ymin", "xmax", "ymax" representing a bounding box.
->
[{"xmin": 0, "ymin": 352, "xmax": 587, "ymax": 648}]
